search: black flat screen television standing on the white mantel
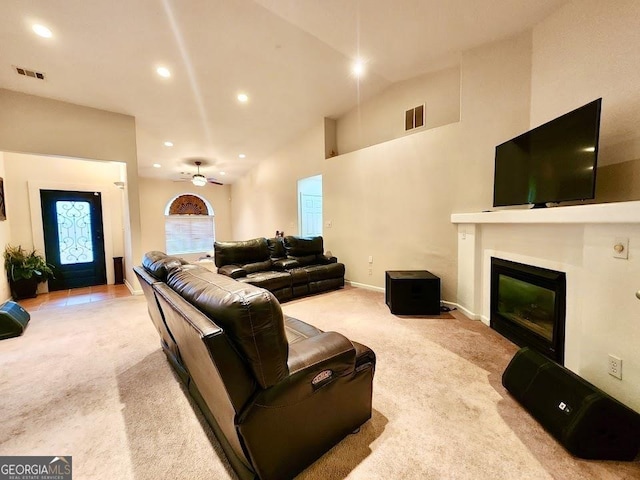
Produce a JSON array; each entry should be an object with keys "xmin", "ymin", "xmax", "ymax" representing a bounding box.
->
[{"xmin": 493, "ymin": 98, "xmax": 602, "ymax": 207}]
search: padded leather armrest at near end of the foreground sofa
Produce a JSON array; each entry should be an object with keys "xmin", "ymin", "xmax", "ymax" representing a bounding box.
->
[{"xmin": 255, "ymin": 332, "xmax": 356, "ymax": 407}]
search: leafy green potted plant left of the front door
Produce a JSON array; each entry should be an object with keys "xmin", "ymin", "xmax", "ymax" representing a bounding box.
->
[{"xmin": 4, "ymin": 245, "xmax": 53, "ymax": 300}]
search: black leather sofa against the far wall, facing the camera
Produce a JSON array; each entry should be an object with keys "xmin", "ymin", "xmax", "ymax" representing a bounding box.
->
[{"xmin": 214, "ymin": 236, "xmax": 345, "ymax": 301}]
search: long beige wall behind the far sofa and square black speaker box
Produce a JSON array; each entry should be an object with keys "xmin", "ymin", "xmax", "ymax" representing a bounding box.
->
[{"xmin": 232, "ymin": 34, "xmax": 531, "ymax": 301}]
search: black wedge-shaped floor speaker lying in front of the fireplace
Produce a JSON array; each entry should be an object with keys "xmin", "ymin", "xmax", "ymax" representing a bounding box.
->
[{"xmin": 502, "ymin": 347, "xmax": 640, "ymax": 460}]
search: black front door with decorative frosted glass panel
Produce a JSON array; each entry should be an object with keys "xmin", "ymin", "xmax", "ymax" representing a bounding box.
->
[{"xmin": 40, "ymin": 190, "xmax": 107, "ymax": 291}]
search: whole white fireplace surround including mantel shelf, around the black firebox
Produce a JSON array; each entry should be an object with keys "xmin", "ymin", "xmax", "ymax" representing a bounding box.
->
[{"xmin": 451, "ymin": 201, "xmax": 640, "ymax": 411}]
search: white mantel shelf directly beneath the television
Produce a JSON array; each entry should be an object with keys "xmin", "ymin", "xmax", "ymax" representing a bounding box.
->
[{"xmin": 451, "ymin": 201, "xmax": 640, "ymax": 227}]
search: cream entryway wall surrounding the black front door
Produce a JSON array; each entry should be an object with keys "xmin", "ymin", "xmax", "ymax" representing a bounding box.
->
[{"xmin": 4, "ymin": 152, "xmax": 124, "ymax": 289}]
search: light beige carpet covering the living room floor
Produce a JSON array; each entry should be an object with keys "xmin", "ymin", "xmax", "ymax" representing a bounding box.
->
[{"xmin": 0, "ymin": 287, "xmax": 640, "ymax": 480}]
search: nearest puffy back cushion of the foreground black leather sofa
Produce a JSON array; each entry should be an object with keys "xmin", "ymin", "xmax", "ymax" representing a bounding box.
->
[{"xmin": 167, "ymin": 264, "xmax": 289, "ymax": 388}]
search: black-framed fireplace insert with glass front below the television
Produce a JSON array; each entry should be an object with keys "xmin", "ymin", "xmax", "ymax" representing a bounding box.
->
[{"xmin": 490, "ymin": 257, "xmax": 566, "ymax": 365}]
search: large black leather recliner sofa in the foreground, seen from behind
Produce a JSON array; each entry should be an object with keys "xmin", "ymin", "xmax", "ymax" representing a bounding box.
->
[{"xmin": 134, "ymin": 252, "xmax": 376, "ymax": 480}]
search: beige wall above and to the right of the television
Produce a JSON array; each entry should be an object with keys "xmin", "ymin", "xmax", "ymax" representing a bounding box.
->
[{"xmin": 531, "ymin": 0, "xmax": 640, "ymax": 201}]
